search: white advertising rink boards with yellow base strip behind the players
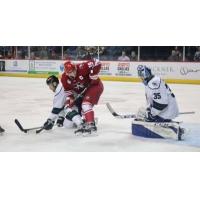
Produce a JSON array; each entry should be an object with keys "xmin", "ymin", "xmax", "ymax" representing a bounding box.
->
[{"xmin": 0, "ymin": 60, "xmax": 200, "ymax": 84}]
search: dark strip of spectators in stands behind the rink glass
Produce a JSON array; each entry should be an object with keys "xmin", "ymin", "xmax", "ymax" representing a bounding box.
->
[{"xmin": 0, "ymin": 46, "xmax": 200, "ymax": 61}]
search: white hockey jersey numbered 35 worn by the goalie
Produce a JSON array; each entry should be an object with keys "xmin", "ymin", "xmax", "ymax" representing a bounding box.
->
[{"xmin": 145, "ymin": 76, "xmax": 179, "ymax": 119}]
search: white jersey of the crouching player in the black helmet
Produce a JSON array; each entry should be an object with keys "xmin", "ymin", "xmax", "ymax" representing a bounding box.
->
[{"xmin": 48, "ymin": 83, "xmax": 67, "ymax": 121}]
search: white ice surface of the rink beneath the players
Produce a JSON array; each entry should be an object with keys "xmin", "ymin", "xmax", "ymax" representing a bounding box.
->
[{"xmin": 0, "ymin": 77, "xmax": 200, "ymax": 152}]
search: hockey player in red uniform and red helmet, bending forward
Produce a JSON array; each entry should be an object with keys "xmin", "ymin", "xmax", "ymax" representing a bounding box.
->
[{"xmin": 61, "ymin": 59, "xmax": 104, "ymax": 134}]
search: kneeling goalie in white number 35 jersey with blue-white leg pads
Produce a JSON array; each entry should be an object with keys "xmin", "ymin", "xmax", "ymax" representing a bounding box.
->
[{"xmin": 132, "ymin": 65, "xmax": 184, "ymax": 140}]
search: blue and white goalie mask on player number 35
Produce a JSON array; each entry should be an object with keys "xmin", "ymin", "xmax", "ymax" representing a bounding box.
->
[{"xmin": 137, "ymin": 65, "xmax": 153, "ymax": 85}]
